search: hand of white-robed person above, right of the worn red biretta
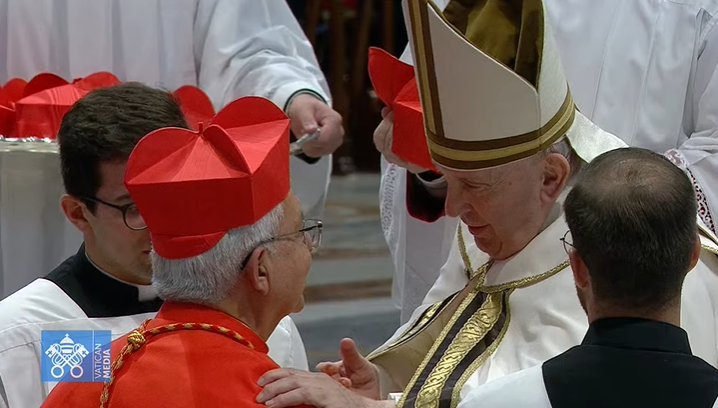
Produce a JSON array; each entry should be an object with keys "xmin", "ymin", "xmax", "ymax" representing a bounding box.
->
[{"xmin": 287, "ymin": 94, "xmax": 344, "ymax": 157}]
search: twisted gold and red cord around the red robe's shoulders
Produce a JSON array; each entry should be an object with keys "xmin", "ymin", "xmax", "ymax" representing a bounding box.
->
[{"xmin": 100, "ymin": 319, "xmax": 254, "ymax": 408}]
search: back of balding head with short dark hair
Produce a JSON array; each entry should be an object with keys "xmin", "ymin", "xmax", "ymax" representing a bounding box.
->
[{"xmin": 564, "ymin": 148, "xmax": 697, "ymax": 310}]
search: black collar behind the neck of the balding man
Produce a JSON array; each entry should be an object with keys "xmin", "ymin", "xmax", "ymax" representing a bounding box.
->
[{"xmin": 581, "ymin": 317, "xmax": 692, "ymax": 354}]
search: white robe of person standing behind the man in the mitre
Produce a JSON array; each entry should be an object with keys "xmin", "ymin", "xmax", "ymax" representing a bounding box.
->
[{"xmin": 380, "ymin": 0, "xmax": 718, "ymax": 322}]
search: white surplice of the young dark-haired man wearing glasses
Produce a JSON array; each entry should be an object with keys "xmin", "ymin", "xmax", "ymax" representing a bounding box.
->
[{"xmin": 0, "ymin": 279, "xmax": 308, "ymax": 408}]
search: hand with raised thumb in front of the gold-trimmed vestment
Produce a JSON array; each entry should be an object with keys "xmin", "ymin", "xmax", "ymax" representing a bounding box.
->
[{"xmin": 317, "ymin": 339, "xmax": 380, "ymax": 399}]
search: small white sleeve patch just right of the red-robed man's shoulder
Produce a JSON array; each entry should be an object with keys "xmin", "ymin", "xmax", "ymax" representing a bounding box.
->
[{"xmin": 267, "ymin": 316, "xmax": 309, "ymax": 370}]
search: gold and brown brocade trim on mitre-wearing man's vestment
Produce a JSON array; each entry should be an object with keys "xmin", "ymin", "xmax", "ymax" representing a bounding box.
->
[{"xmin": 368, "ymin": 229, "xmax": 568, "ymax": 408}]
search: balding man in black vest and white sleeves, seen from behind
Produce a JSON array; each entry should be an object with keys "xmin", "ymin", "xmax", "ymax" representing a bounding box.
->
[{"xmin": 459, "ymin": 148, "xmax": 718, "ymax": 408}]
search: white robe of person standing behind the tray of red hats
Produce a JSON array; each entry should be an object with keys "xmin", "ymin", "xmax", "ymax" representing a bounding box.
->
[{"xmin": 0, "ymin": 0, "xmax": 331, "ymax": 298}]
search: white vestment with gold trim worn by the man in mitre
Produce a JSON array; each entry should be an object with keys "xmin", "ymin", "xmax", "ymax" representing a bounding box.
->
[{"xmin": 370, "ymin": 189, "xmax": 718, "ymax": 398}]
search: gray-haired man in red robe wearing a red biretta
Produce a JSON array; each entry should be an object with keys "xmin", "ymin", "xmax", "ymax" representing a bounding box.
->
[{"xmin": 43, "ymin": 97, "xmax": 322, "ymax": 408}]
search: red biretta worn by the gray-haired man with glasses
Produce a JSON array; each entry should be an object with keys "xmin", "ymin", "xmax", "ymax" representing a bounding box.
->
[{"xmin": 125, "ymin": 97, "xmax": 290, "ymax": 259}]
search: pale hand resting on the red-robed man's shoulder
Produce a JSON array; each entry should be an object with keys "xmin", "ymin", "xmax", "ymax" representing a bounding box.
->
[{"xmin": 257, "ymin": 368, "xmax": 384, "ymax": 408}]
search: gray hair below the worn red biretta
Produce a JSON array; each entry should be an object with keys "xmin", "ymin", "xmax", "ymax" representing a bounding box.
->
[{"xmin": 151, "ymin": 204, "xmax": 284, "ymax": 305}]
